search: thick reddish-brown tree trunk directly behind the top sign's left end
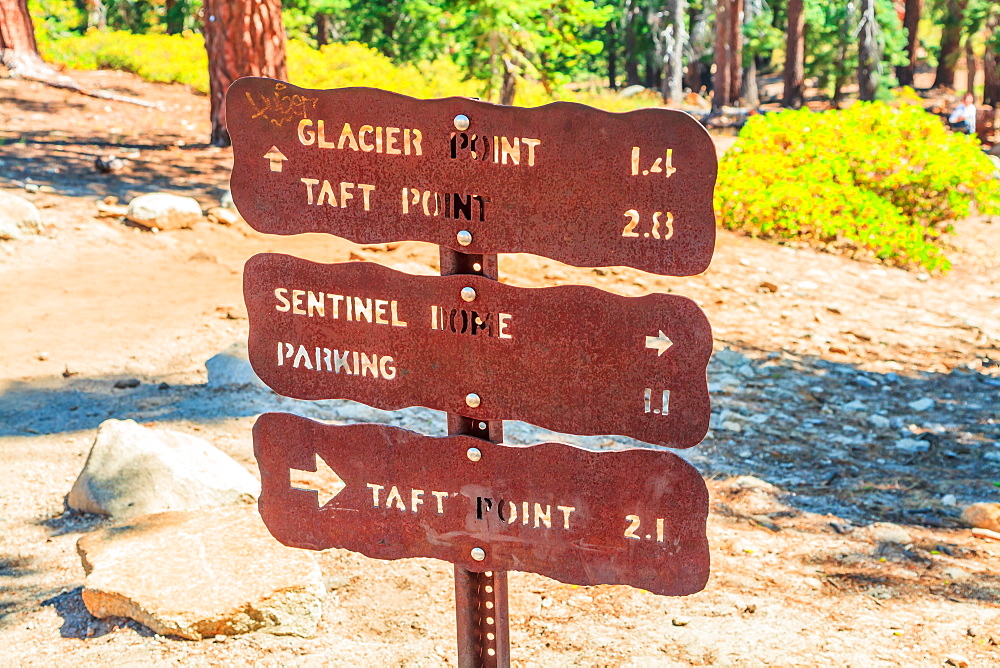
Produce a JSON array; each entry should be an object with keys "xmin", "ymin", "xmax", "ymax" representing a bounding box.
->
[{"xmin": 203, "ymin": 0, "xmax": 288, "ymax": 146}]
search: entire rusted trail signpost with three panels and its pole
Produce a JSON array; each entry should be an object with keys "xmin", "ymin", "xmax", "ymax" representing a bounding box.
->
[{"xmin": 227, "ymin": 78, "xmax": 717, "ymax": 666}]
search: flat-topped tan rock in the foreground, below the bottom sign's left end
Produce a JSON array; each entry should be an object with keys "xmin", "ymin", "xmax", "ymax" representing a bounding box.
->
[{"xmin": 77, "ymin": 506, "xmax": 326, "ymax": 640}]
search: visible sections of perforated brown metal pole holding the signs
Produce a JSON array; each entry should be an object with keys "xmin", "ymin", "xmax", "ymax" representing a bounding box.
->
[{"xmin": 440, "ymin": 248, "xmax": 510, "ymax": 668}]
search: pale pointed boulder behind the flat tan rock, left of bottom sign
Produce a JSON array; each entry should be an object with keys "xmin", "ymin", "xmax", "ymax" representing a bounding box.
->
[{"xmin": 66, "ymin": 420, "xmax": 260, "ymax": 519}]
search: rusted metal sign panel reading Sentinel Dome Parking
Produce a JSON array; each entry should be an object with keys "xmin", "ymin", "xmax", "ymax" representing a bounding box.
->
[{"xmin": 244, "ymin": 254, "xmax": 712, "ymax": 448}]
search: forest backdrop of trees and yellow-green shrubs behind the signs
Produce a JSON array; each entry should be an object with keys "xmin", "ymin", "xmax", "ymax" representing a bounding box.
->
[{"xmin": 0, "ymin": 0, "xmax": 1000, "ymax": 272}]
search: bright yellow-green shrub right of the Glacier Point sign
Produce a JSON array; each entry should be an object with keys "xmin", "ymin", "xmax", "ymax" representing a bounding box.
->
[{"xmin": 716, "ymin": 102, "xmax": 1000, "ymax": 270}]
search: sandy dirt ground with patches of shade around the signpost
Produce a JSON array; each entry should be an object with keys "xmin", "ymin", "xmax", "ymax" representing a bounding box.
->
[{"xmin": 0, "ymin": 72, "xmax": 1000, "ymax": 666}]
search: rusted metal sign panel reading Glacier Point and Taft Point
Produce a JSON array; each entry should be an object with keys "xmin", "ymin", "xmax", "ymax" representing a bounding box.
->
[{"xmin": 226, "ymin": 78, "xmax": 717, "ymax": 276}]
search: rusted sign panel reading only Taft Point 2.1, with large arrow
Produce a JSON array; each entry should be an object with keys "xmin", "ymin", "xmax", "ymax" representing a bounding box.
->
[{"xmin": 253, "ymin": 413, "xmax": 709, "ymax": 596}]
